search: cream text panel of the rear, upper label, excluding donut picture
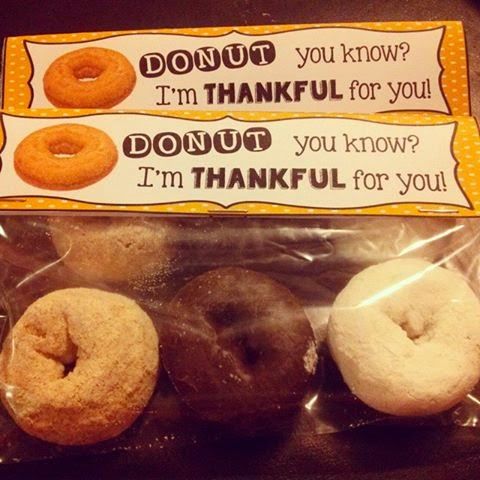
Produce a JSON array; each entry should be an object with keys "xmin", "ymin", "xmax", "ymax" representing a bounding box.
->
[{"xmin": 26, "ymin": 27, "xmax": 449, "ymax": 113}]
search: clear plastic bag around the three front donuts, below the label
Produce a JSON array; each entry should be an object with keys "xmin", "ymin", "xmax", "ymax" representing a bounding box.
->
[{"xmin": 0, "ymin": 216, "xmax": 480, "ymax": 462}]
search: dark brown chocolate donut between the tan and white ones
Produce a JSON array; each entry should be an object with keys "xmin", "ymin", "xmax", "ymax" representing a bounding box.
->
[{"xmin": 160, "ymin": 267, "xmax": 317, "ymax": 425}]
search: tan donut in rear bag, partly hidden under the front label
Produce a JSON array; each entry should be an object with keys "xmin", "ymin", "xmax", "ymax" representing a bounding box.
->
[{"xmin": 48, "ymin": 216, "xmax": 176, "ymax": 283}]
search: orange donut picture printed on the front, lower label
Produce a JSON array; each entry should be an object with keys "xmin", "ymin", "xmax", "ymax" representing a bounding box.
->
[{"xmin": 14, "ymin": 124, "xmax": 118, "ymax": 190}]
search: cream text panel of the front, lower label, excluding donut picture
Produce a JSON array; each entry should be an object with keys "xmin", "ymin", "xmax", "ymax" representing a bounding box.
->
[{"xmin": 0, "ymin": 114, "xmax": 470, "ymax": 209}]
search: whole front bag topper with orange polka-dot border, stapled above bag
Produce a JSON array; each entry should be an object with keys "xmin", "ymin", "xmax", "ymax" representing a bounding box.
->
[{"xmin": 0, "ymin": 112, "xmax": 480, "ymax": 215}]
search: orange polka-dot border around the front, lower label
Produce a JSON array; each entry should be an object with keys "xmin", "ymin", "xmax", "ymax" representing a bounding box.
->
[{"xmin": 0, "ymin": 109, "xmax": 480, "ymax": 217}]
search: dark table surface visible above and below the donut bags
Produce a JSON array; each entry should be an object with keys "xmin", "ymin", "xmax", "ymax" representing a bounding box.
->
[{"xmin": 0, "ymin": 0, "xmax": 480, "ymax": 480}]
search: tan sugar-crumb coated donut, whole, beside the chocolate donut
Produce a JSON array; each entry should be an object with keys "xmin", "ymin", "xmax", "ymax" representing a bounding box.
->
[{"xmin": 0, "ymin": 288, "xmax": 159, "ymax": 445}]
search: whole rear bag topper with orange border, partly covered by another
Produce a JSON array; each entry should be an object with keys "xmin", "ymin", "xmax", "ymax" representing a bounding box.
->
[{"xmin": 0, "ymin": 22, "xmax": 469, "ymax": 115}]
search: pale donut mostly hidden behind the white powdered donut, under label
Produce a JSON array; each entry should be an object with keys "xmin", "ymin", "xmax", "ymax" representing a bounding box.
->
[{"xmin": 326, "ymin": 217, "xmax": 455, "ymax": 271}]
